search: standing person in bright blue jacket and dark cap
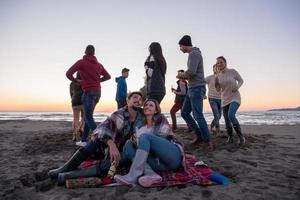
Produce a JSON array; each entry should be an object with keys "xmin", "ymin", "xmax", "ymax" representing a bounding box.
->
[{"xmin": 116, "ymin": 68, "xmax": 129, "ymax": 109}]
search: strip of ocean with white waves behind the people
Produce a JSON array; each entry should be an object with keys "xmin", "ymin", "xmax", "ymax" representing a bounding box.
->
[{"xmin": 0, "ymin": 111, "xmax": 300, "ymax": 125}]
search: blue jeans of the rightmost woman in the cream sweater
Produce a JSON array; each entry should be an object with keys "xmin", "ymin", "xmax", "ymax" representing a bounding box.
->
[{"xmin": 223, "ymin": 102, "xmax": 240, "ymax": 128}]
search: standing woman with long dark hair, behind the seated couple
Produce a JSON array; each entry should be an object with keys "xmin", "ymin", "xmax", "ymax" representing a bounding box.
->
[{"xmin": 145, "ymin": 42, "xmax": 167, "ymax": 103}]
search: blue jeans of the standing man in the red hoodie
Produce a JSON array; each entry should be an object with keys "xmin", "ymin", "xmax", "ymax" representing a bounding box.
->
[{"xmin": 81, "ymin": 91, "xmax": 101, "ymax": 142}]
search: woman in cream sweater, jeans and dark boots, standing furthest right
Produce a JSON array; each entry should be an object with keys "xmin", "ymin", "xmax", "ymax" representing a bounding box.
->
[{"xmin": 215, "ymin": 56, "xmax": 245, "ymax": 145}]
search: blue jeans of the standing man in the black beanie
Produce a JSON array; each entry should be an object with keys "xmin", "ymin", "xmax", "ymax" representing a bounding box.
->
[{"xmin": 181, "ymin": 85, "xmax": 210, "ymax": 141}]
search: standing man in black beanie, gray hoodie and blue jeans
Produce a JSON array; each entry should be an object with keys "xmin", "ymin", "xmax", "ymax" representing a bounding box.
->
[{"xmin": 176, "ymin": 35, "xmax": 212, "ymax": 149}]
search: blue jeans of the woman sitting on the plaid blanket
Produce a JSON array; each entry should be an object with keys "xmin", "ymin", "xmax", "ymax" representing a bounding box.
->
[{"xmin": 123, "ymin": 134, "xmax": 182, "ymax": 171}]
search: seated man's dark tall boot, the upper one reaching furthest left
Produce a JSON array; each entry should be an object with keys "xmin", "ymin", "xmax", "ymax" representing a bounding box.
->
[{"xmin": 48, "ymin": 150, "xmax": 86, "ymax": 178}]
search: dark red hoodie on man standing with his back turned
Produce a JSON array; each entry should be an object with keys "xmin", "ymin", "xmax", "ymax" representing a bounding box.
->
[{"xmin": 66, "ymin": 55, "xmax": 110, "ymax": 92}]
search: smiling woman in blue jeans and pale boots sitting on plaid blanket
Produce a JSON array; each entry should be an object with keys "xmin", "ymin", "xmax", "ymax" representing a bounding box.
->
[{"xmin": 114, "ymin": 99, "xmax": 184, "ymax": 187}]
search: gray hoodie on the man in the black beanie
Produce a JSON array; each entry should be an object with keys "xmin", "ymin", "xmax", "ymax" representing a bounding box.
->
[{"xmin": 181, "ymin": 47, "xmax": 205, "ymax": 88}]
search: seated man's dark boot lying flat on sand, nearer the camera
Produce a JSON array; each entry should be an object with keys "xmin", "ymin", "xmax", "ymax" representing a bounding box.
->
[{"xmin": 57, "ymin": 165, "xmax": 100, "ymax": 186}]
